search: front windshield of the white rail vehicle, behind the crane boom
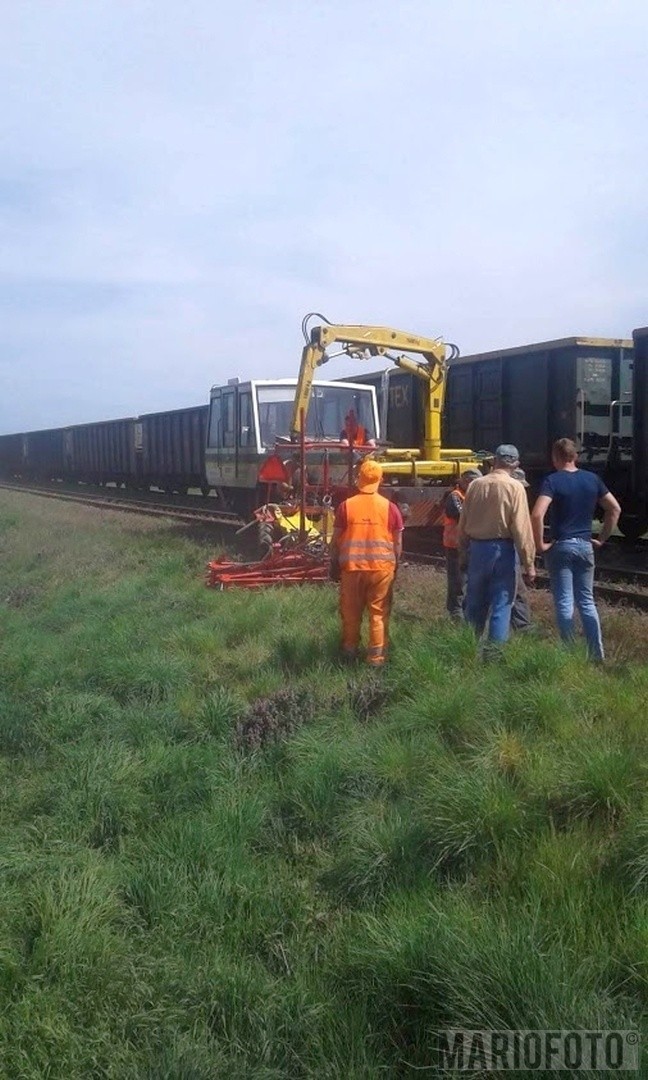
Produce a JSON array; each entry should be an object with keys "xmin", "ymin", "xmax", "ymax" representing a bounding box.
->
[{"xmin": 252, "ymin": 386, "xmax": 376, "ymax": 447}]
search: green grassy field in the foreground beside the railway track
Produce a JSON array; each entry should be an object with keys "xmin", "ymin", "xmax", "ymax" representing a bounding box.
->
[{"xmin": 0, "ymin": 492, "xmax": 648, "ymax": 1080}]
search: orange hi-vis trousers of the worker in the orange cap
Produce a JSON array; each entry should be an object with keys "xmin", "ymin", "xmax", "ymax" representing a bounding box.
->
[{"xmin": 340, "ymin": 569, "xmax": 394, "ymax": 665}]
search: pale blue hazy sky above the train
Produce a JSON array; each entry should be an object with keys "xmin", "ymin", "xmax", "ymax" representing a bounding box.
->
[{"xmin": 0, "ymin": 0, "xmax": 648, "ymax": 432}]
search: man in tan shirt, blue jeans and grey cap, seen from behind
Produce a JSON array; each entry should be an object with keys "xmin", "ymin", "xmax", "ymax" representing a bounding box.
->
[{"xmin": 459, "ymin": 444, "xmax": 536, "ymax": 644}]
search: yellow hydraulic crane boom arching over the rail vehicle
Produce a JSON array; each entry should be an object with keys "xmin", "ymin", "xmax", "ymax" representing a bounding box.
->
[{"xmin": 291, "ymin": 323, "xmax": 458, "ymax": 462}]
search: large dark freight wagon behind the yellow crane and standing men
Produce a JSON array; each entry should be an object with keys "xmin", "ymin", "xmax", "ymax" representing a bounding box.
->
[{"xmin": 343, "ymin": 338, "xmax": 648, "ymax": 537}]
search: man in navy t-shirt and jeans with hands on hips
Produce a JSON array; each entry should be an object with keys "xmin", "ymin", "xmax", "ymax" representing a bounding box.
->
[{"xmin": 531, "ymin": 438, "xmax": 621, "ymax": 663}]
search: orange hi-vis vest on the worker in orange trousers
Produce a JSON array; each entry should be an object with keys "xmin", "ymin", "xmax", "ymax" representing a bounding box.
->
[{"xmin": 339, "ymin": 491, "xmax": 396, "ymax": 572}]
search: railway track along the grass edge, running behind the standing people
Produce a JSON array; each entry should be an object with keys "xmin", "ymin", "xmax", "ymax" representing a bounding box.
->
[{"xmin": 5, "ymin": 482, "xmax": 648, "ymax": 611}]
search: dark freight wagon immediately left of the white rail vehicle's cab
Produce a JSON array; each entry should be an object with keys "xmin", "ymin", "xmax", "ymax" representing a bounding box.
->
[{"xmin": 139, "ymin": 405, "xmax": 210, "ymax": 495}]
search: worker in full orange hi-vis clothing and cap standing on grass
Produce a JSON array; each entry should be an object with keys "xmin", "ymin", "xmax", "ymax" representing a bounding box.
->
[{"xmin": 330, "ymin": 459, "xmax": 403, "ymax": 666}]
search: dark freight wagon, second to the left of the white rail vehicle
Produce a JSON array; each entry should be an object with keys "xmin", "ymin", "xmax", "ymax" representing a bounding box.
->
[{"xmin": 63, "ymin": 417, "xmax": 137, "ymax": 486}]
